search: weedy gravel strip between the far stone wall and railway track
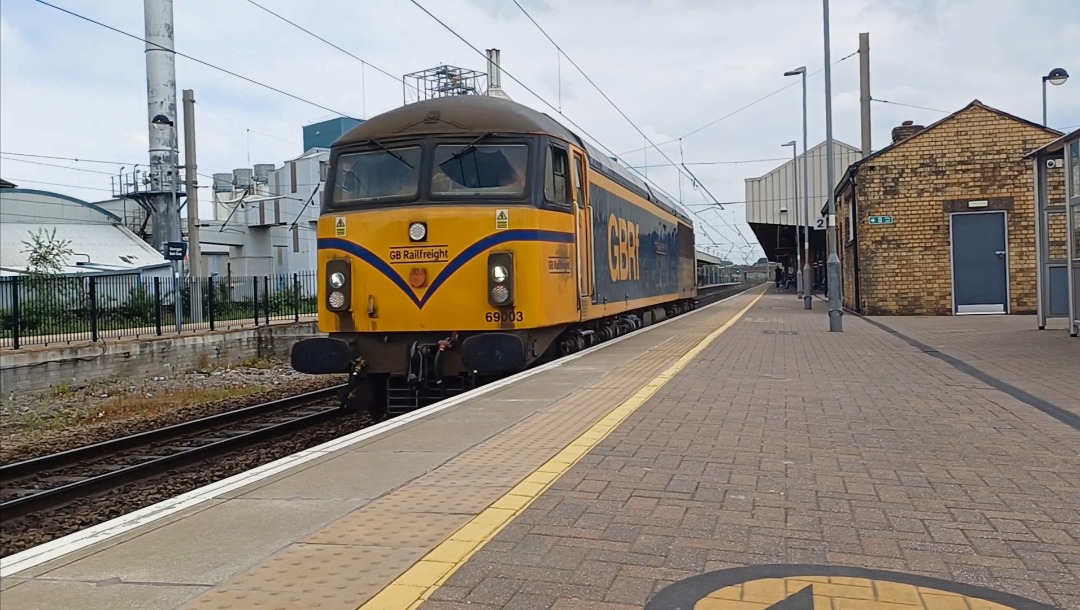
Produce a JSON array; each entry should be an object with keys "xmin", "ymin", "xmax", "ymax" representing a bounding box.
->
[{"xmin": 0, "ymin": 361, "xmax": 348, "ymax": 463}]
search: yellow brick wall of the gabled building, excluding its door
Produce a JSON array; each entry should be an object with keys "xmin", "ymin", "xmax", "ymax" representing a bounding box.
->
[{"xmin": 837, "ymin": 104, "xmax": 1064, "ymax": 315}]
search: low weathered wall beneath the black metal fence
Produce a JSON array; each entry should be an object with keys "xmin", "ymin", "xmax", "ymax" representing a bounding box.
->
[{"xmin": 0, "ymin": 322, "xmax": 319, "ymax": 394}]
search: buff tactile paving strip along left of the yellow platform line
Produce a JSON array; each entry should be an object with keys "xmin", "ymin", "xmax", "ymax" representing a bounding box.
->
[{"xmin": 181, "ymin": 291, "xmax": 742, "ymax": 610}]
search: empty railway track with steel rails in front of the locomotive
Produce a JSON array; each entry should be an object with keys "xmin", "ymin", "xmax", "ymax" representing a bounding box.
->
[{"xmin": 0, "ymin": 385, "xmax": 341, "ymax": 519}]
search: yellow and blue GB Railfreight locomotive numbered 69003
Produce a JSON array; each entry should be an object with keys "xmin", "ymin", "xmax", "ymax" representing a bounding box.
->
[{"xmin": 291, "ymin": 95, "xmax": 697, "ymax": 411}]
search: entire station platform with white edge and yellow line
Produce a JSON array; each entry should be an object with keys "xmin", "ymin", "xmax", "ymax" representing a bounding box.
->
[{"xmin": 0, "ymin": 285, "xmax": 1080, "ymax": 610}]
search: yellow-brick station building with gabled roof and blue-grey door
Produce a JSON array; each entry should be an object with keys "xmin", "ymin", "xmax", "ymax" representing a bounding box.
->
[{"xmin": 836, "ymin": 99, "xmax": 1066, "ymax": 315}]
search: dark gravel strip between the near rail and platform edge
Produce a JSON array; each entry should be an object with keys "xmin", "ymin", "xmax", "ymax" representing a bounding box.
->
[{"xmin": 0, "ymin": 414, "xmax": 375, "ymax": 557}]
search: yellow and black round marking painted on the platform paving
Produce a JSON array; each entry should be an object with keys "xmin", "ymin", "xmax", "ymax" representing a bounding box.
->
[{"xmin": 645, "ymin": 564, "xmax": 1051, "ymax": 610}]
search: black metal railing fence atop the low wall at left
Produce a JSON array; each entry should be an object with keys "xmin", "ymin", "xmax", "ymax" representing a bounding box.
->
[{"xmin": 0, "ymin": 271, "xmax": 319, "ymax": 350}]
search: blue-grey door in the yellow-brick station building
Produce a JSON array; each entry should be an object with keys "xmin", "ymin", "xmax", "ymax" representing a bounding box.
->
[{"xmin": 953, "ymin": 212, "xmax": 1009, "ymax": 314}]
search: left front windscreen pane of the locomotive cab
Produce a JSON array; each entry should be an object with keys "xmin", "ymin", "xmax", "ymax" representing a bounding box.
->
[{"xmin": 334, "ymin": 146, "xmax": 420, "ymax": 204}]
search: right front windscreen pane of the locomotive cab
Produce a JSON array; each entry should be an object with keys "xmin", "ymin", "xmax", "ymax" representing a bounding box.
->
[{"xmin": 431, "ymin": 144, "xmax": 529, "ymax": 198}]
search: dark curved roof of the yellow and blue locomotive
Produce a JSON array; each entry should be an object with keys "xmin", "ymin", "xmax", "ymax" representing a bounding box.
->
[{"xmin": 333, "ymin": 95, "xmax": 692, "ymax": 225}]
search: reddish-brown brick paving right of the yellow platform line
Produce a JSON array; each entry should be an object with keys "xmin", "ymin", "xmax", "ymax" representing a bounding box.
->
[{"xmin": 421, "ymin": 295, "xmax": 1080, "ymax": 610}]
